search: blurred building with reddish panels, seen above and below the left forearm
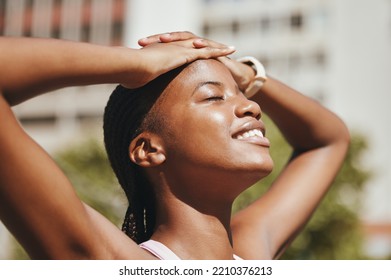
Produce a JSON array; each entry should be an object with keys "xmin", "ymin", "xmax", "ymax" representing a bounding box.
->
[{"xmin": 0, "ymin": 0, "xmax": 125, "ymax": 153}]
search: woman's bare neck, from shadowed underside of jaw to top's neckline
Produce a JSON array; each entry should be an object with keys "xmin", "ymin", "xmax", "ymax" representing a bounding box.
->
[{"xmin": 147, "ymin": 168, "xmax": 242, "ymax": 259}]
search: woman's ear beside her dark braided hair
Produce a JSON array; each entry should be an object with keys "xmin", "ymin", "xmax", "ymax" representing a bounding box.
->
[{"xmin": 129, "ymin": 132, "xmax": 166, "ymax": 167}]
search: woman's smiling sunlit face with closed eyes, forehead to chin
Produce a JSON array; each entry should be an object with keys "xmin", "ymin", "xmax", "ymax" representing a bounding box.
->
[{"xmin": 153, "ymin": 59, "xmax": 273, "ymax": 191}]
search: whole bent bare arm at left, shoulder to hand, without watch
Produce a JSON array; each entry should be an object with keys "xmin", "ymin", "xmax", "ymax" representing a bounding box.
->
[{"xmin": 0, "ymin": 38, "xmax": 233, "ymax": 259}]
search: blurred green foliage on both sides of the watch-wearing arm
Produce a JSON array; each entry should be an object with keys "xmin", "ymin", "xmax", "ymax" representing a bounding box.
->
[{"xmin": 234, "ymin": 117, "xmax": 371, "ymax": 260}]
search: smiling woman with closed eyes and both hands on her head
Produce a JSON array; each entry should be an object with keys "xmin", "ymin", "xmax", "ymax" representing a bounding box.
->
[{"xmin": 0, "ymin": 32, "xmax": 349, "ymax": 259}]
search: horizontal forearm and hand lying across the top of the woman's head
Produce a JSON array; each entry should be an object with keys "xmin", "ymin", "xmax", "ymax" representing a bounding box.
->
[{"xmin": 0, "ymin": 37, "xmax": 234, "ymax": 105}]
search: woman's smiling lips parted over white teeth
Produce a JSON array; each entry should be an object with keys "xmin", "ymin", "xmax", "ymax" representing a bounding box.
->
[{"xmin": 232, "ymin": 121, "xmax": 270, "ymax": 147}]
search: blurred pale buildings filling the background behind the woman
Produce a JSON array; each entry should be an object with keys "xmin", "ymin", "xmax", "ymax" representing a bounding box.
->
[{"xmin": 0, "ymin": 0, "xmax": 391, "ymax": 258}]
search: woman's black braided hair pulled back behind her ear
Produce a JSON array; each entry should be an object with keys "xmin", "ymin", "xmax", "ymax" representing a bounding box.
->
[{"xmin": 103, "ymin": 66, "xmax": 185, "ymax": 244}]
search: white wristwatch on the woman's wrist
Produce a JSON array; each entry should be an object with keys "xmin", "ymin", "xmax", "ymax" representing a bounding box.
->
[{"xmin": 237, "ymin": 56, "xmax": 267, "ymax": 98}]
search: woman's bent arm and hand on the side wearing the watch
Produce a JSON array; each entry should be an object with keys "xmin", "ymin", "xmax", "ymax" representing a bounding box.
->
[{"xmin": 222, "ymin": 59, "xmax": 349, "ymax": 259}]
